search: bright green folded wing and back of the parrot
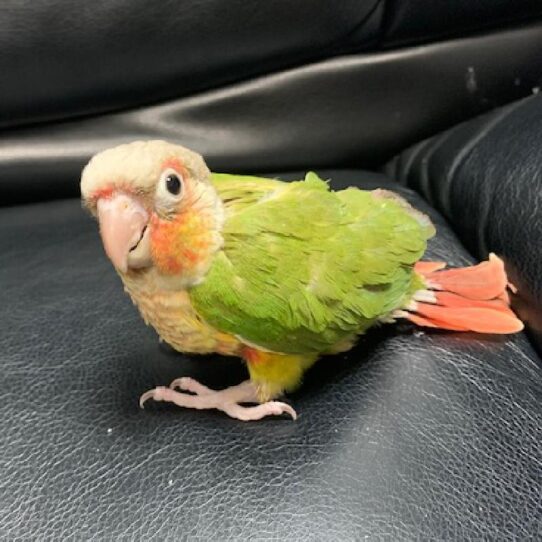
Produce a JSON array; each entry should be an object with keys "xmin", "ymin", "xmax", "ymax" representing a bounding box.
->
[{"xmin": 190, "ymin": 173, "xmax": 434, "ymax": 353}]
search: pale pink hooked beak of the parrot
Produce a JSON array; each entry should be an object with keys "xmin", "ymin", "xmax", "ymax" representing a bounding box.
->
[{"xmin": 97, "ymin": 193, "xmax": 149, "ymax": 273}]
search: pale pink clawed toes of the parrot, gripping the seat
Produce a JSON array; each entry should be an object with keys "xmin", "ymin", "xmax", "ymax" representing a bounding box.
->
[{"xmin": 139, "ymin": 377, "xmax": 297, "ymax": 421}]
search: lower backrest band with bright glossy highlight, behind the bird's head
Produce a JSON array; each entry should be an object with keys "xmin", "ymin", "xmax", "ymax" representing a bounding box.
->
[{"xmin": 0, "ymin": 25, "xmax": 542, "ymax": 208}]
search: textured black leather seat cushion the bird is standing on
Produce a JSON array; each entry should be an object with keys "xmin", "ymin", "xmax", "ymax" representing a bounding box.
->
[{"xmin": 0, "ymin": 172, "xmax": 542, "ymax": 541}]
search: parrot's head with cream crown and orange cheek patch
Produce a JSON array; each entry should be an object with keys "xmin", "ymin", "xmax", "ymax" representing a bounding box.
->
[{"xmin": 81, "ymin": 141, "xmax": 224, "ymax": 286}]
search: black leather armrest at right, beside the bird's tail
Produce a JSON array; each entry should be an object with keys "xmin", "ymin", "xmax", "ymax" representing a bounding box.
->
[{"xmin": 387, "ymin": 95, "xmax": 542, "ymax": 352}]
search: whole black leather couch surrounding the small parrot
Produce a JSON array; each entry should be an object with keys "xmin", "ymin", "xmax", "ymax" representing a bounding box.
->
[{"xmin": 0, "ymin": 0, "xmax": 542, "ymax": 540}]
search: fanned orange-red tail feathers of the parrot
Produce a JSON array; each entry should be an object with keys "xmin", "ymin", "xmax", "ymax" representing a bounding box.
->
[{"xmin": 404, "ymin": 254, "xmax": 523, "ymax": 334}]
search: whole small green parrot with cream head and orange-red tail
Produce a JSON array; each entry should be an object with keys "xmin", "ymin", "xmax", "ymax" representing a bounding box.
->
[{"xmin": 80, "ymin": 140, "xmax": 523, "ymax": 421}]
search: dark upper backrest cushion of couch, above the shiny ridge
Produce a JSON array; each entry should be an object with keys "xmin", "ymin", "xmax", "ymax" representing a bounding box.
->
[{"xmin": 0, "ymin": 0, "xmax": 542, "ymax": 127}]
